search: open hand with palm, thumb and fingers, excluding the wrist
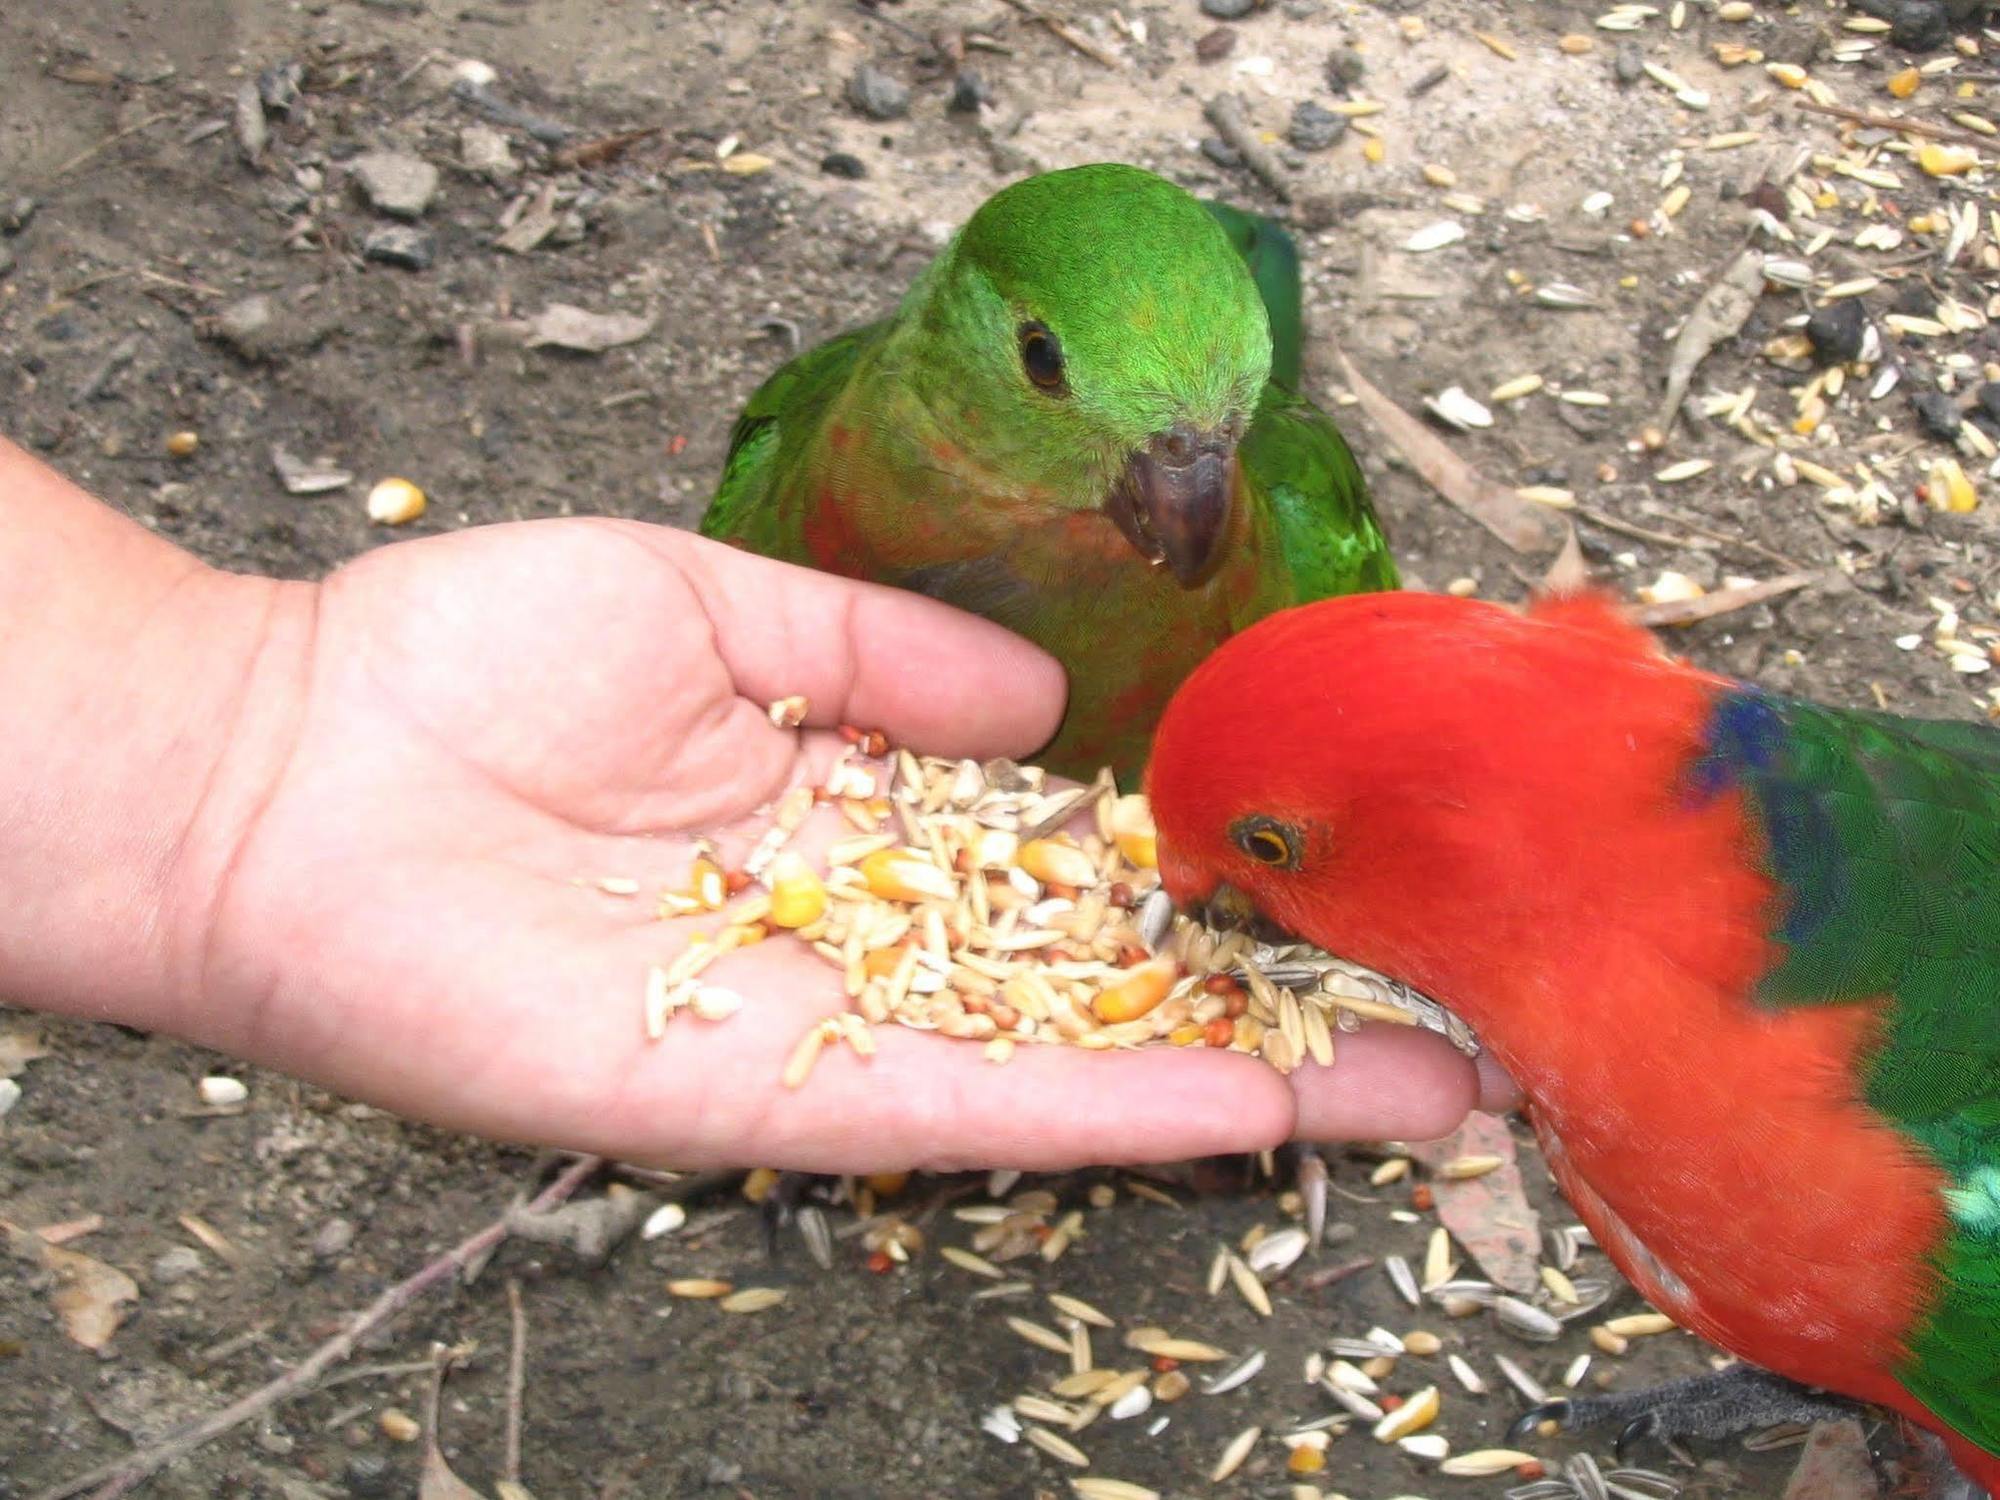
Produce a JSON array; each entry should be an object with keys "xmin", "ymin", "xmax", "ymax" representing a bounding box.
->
[{"xmin": 182, "ymin": 520, "xmax": 1476, "ymax": 1170}]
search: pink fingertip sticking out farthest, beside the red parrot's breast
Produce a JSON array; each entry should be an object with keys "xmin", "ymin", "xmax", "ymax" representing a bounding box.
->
[{"xmin": 1292, "ymin": 1026, "xmax": 1480, "ymax": 1140}]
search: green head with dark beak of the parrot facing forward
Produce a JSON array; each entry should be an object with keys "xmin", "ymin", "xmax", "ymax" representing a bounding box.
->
[{"xmin": 908, "ymin": 164, "xmax": 1272, "ymax": 588}]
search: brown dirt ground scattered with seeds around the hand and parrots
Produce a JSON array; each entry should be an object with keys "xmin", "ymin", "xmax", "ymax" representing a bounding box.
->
[{"xmin": 0, "ymin": 0, "xmax": 2000, "ymax": 1500}]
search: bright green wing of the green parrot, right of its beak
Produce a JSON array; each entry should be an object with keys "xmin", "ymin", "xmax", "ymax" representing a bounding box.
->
[{"xmin": 1242, "ymin": 382, "xmax": 1398, "ymax": 602}]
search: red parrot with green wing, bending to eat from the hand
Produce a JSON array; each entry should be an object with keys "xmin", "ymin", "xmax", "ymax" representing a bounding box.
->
[{"xmin": 1148, "ymin": 594, "xmax": 2000, "ymax": 1496}]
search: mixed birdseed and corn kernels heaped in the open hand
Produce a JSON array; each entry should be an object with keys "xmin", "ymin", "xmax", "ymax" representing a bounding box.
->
[{"xmin": 646, "ymin": 720, "xmax": 1476, "ymax": 1088}]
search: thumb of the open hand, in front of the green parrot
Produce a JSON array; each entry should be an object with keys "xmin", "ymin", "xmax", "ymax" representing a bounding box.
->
[{"xmin": 646, "ymin": 528, "xmax": 1068, "ymax": 758}]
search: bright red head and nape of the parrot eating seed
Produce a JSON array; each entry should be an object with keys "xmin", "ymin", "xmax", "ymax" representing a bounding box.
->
[{"xmin": 1146, "ymin": 592, "xmax": 1716, "ymax": 1032}]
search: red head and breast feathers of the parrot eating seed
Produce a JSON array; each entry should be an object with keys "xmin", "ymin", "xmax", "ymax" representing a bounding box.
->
[{"xmin": 1148, "ymin": 594, "xmax": 1976, "ymax": 1492}]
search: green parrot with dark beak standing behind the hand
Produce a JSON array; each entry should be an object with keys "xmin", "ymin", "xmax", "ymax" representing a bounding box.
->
[{"xmin": 700, "ymin": 164, "xmax": 1396, "ymax": 786}]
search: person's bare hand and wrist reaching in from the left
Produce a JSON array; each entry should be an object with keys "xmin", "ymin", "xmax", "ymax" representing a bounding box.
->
[{"xmin": 0, "ymin": 442, "xmax": 1512, "ymax": 1170}]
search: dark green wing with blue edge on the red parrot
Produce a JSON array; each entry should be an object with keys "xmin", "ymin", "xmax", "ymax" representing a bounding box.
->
[{"xmin": 1702, "ymin": 690, "xmax": 2000, "ymax": 1452}]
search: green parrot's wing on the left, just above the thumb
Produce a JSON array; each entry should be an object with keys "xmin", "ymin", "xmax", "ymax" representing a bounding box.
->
[{"xmin": 700, "ymin": 320, "xmax": 888, "ymax": 562}]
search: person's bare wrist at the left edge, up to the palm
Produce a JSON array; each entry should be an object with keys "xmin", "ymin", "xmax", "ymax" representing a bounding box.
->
[{"xmin": 0, "ymin": 444, "xmax": 314, "ymax": 1032}]
